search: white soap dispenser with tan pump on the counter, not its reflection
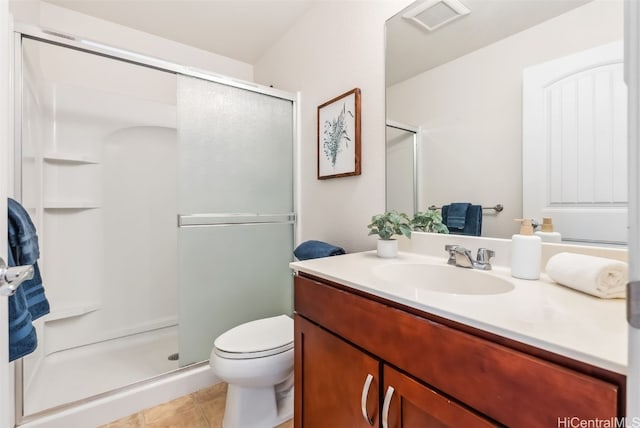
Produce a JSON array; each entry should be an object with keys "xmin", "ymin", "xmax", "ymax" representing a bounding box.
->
[{"xmin": 511, "ymin": 218, "xmax": 542, "ymax": 279}]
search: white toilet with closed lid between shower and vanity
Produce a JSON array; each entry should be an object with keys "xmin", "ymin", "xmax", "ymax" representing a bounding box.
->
[{"xmin": 209, "ymin": 315, "xmax": 293, "ymax": 428}]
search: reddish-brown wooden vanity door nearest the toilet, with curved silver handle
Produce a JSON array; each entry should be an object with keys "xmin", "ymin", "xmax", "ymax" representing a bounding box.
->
[{"xmin": 294, "ymin": 315, "xmax": 381, "ymax": 428}]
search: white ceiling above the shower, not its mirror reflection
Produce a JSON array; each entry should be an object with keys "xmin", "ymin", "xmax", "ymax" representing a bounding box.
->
[{"xmin": 39, "ymin": 0, "xmax": 320, "ymax": 64}]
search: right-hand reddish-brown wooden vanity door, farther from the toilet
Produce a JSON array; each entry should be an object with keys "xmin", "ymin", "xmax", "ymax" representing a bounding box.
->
[{"xmin": 382, "ymin": 366, "xmax": 500, "ymax": 428}]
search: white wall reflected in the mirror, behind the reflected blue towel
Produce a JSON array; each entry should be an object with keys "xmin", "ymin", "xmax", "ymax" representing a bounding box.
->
[{"xmin": 387, "ymin": 0, "xmax": 623, "ymax": 238}]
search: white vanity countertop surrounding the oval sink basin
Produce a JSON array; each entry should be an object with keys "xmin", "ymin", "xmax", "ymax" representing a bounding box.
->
[{"xmin": 290, "ymin": 251, "xmax": 627, "ymax": 374}]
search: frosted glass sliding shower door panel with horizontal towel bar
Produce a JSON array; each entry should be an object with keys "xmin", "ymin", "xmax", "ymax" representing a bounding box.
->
[{"xmin": 178, "ymin": 76, "xmax": 295, "ymax": 366}]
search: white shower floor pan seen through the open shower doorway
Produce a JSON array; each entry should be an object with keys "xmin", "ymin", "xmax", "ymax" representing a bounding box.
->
[{"xmin": 24, "ymin": 326, "xmax": 178, "ymax": 415}]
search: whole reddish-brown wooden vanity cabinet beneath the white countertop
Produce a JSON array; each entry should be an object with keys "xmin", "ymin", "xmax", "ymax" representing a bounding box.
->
[{"xmin": 294, "ymin": 273, "xmax": 625, "ymax": 428}]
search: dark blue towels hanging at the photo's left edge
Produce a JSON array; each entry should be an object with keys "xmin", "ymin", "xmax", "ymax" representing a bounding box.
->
[{"xmin": 7, "ymin": 198, "xmax": 50, "ymax": 361}]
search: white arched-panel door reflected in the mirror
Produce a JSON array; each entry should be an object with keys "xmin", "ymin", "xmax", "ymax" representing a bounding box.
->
[{"xmin": 522, "ymin": 41, "xmax": 628, "ymax": 243}]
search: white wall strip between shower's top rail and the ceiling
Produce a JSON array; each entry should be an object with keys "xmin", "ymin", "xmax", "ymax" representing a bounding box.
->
[{"xmin": 10, "ymin": 0, "xmax": 253, "ymax": 81}]
